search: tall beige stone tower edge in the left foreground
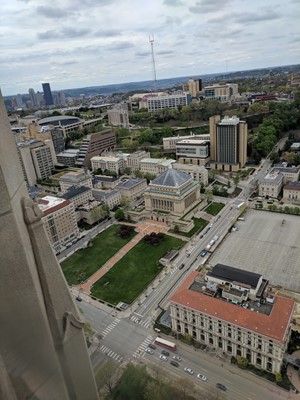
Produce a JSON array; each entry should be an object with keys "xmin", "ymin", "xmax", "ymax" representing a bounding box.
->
[{"xmin": 0, "ymin": 93, "xmax": 98, "ymax": 400}]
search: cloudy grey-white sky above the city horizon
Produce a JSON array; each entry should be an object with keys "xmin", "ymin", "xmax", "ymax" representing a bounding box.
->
[{"xmin": 0, "ymin": 0, "xmax": 300, "ymax": 95}]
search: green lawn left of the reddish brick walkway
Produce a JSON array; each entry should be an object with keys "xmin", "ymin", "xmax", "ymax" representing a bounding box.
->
[{"xmin": 61, "ymin": 225, "xmax": 136, "ymax": 285}]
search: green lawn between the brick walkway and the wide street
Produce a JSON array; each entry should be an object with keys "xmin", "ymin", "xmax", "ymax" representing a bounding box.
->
[{"xmin": 92, "ymin": 235, "xmax": 185, "ymax": 305}]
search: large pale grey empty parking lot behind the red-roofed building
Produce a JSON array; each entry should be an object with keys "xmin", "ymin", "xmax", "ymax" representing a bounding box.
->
[{"xmin": 209, "ymin": 210, "xmax": 300, "ymax": 292}]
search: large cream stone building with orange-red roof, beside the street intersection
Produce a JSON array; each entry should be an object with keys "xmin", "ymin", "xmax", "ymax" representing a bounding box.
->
[{"xmin": 170, "ymin": 267, "xmax": 295, "ymax": 374}]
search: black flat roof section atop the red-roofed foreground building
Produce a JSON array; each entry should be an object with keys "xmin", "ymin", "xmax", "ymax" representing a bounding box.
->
[{"xmin": 207, "ymin": 264, "xmax": 262, "ymax": 288}]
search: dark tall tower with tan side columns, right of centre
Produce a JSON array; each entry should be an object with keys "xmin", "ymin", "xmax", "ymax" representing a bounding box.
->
[{"xmin": 209, "ymin": 115, "xmax": 247, "ymax": 172}]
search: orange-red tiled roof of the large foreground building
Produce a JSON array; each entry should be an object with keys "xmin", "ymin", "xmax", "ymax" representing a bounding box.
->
[{"xmin": 170, "ymin": 272, "xmax": 295, "ymax": 342}]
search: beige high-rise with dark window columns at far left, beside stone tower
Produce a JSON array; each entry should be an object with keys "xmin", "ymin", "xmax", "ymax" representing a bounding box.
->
[{"xmin": 17, "ymin": 139, "xmax": 57, "ymax": 186}]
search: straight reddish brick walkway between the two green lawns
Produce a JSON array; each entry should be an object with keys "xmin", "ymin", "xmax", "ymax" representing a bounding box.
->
[{"xmin": 77, "ymin": 221, "xmax": 169, "ymax": 294}]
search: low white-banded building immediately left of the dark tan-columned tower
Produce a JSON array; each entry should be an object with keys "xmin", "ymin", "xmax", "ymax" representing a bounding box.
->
[{"xmin": 176, "ymin": 139, "xmax": 210, "ymax": 165}]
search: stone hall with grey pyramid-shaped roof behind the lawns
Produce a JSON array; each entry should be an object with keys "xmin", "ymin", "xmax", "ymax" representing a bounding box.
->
[{"xmin": 144, "ymin": 168, "xmax": 200, "ymax": 216}]
